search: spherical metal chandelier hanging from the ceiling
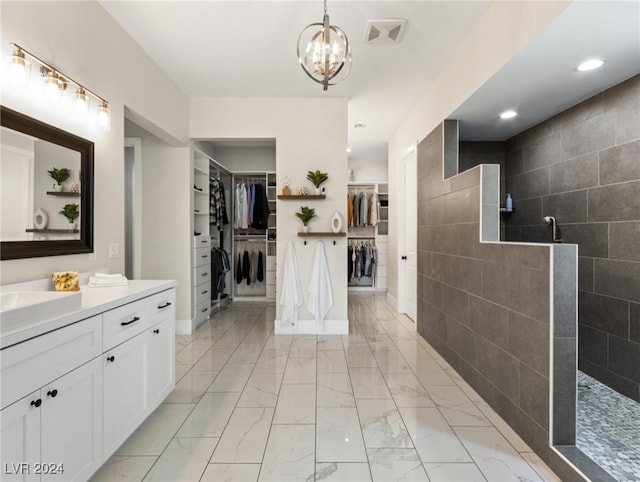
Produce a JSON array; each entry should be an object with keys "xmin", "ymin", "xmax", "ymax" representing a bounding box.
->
[{"xmin": 297, "ymin": 0, "xmax": 351, "ymax": 90}]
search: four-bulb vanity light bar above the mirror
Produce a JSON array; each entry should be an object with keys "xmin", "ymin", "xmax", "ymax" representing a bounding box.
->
[{"xmin": 9, "ymin": 43, "xmax": 111, "ymax": 130}]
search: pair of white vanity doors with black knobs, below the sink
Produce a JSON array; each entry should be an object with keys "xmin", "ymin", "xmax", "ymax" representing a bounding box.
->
[{"xmin": 0, "ymin": 350, "xmax": 103, "ymax": 481}]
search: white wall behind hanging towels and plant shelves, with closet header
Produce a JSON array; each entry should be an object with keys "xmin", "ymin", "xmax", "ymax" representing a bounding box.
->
[{"xmin": 190, "ymin": 98, "xmax": 347, "ymax": 332}]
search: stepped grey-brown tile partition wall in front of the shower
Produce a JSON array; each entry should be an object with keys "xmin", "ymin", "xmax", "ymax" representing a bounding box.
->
[{"xmin": 417, "ymin": 125, "xmax": 580, "ymax": 481}]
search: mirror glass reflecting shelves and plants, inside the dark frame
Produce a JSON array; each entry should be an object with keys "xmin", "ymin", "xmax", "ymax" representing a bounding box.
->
[{"xmin": 0, "ymin": 127, "xmax": 82, "ymax": 241}]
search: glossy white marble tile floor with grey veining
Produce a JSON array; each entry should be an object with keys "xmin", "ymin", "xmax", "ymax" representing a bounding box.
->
[{"xmin": 92, "ymin": 294, "xmax": 559, "ymax": 482}]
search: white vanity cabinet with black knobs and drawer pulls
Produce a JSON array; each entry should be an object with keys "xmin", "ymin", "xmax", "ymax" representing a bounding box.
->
[{"xmin": 0, "ymin": 281, "xmax": 175, "ymax": 482}]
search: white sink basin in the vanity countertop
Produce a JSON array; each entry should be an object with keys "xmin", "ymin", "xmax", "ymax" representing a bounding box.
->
[{"xmin": 0, "ymin": 291, "xmax": 82, "ymax": 334}]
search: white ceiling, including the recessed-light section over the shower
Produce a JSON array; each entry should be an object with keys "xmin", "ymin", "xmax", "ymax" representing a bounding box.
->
[{"xmin": 101, "ymin": 0, "xmax": 640, "ymax": 160}]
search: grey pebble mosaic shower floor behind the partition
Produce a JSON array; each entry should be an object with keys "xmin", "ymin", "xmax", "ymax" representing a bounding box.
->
[{"xmin": 576, "ymin": 371, "xmax": 640, "ymax": 482}]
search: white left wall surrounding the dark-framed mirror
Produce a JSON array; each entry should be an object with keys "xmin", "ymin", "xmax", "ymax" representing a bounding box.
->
[{"xmin": 0, "ymin": 1, "xmax": 189, "ymax": 284}]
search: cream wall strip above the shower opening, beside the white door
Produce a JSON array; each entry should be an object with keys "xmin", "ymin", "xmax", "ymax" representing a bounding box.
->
[{"xmin": 389, "ymin": 0, "xmax": 571, "ymax": 301}]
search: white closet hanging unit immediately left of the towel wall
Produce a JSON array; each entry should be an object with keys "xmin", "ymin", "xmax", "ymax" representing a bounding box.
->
[{"xmin": 230, "ymin": 172, "xmax": 278, "ymax": 301}]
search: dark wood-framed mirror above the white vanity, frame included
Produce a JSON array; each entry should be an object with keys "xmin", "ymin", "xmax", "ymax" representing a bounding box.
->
[{"xmin": 0, "ymin": 106, "xmax": 94, "ymax": 260}]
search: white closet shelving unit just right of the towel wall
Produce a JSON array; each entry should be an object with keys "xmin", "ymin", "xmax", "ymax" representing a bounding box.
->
[{"xmin": 347, "ymin": 182, "xmax": 389, "ymax": 291}]
